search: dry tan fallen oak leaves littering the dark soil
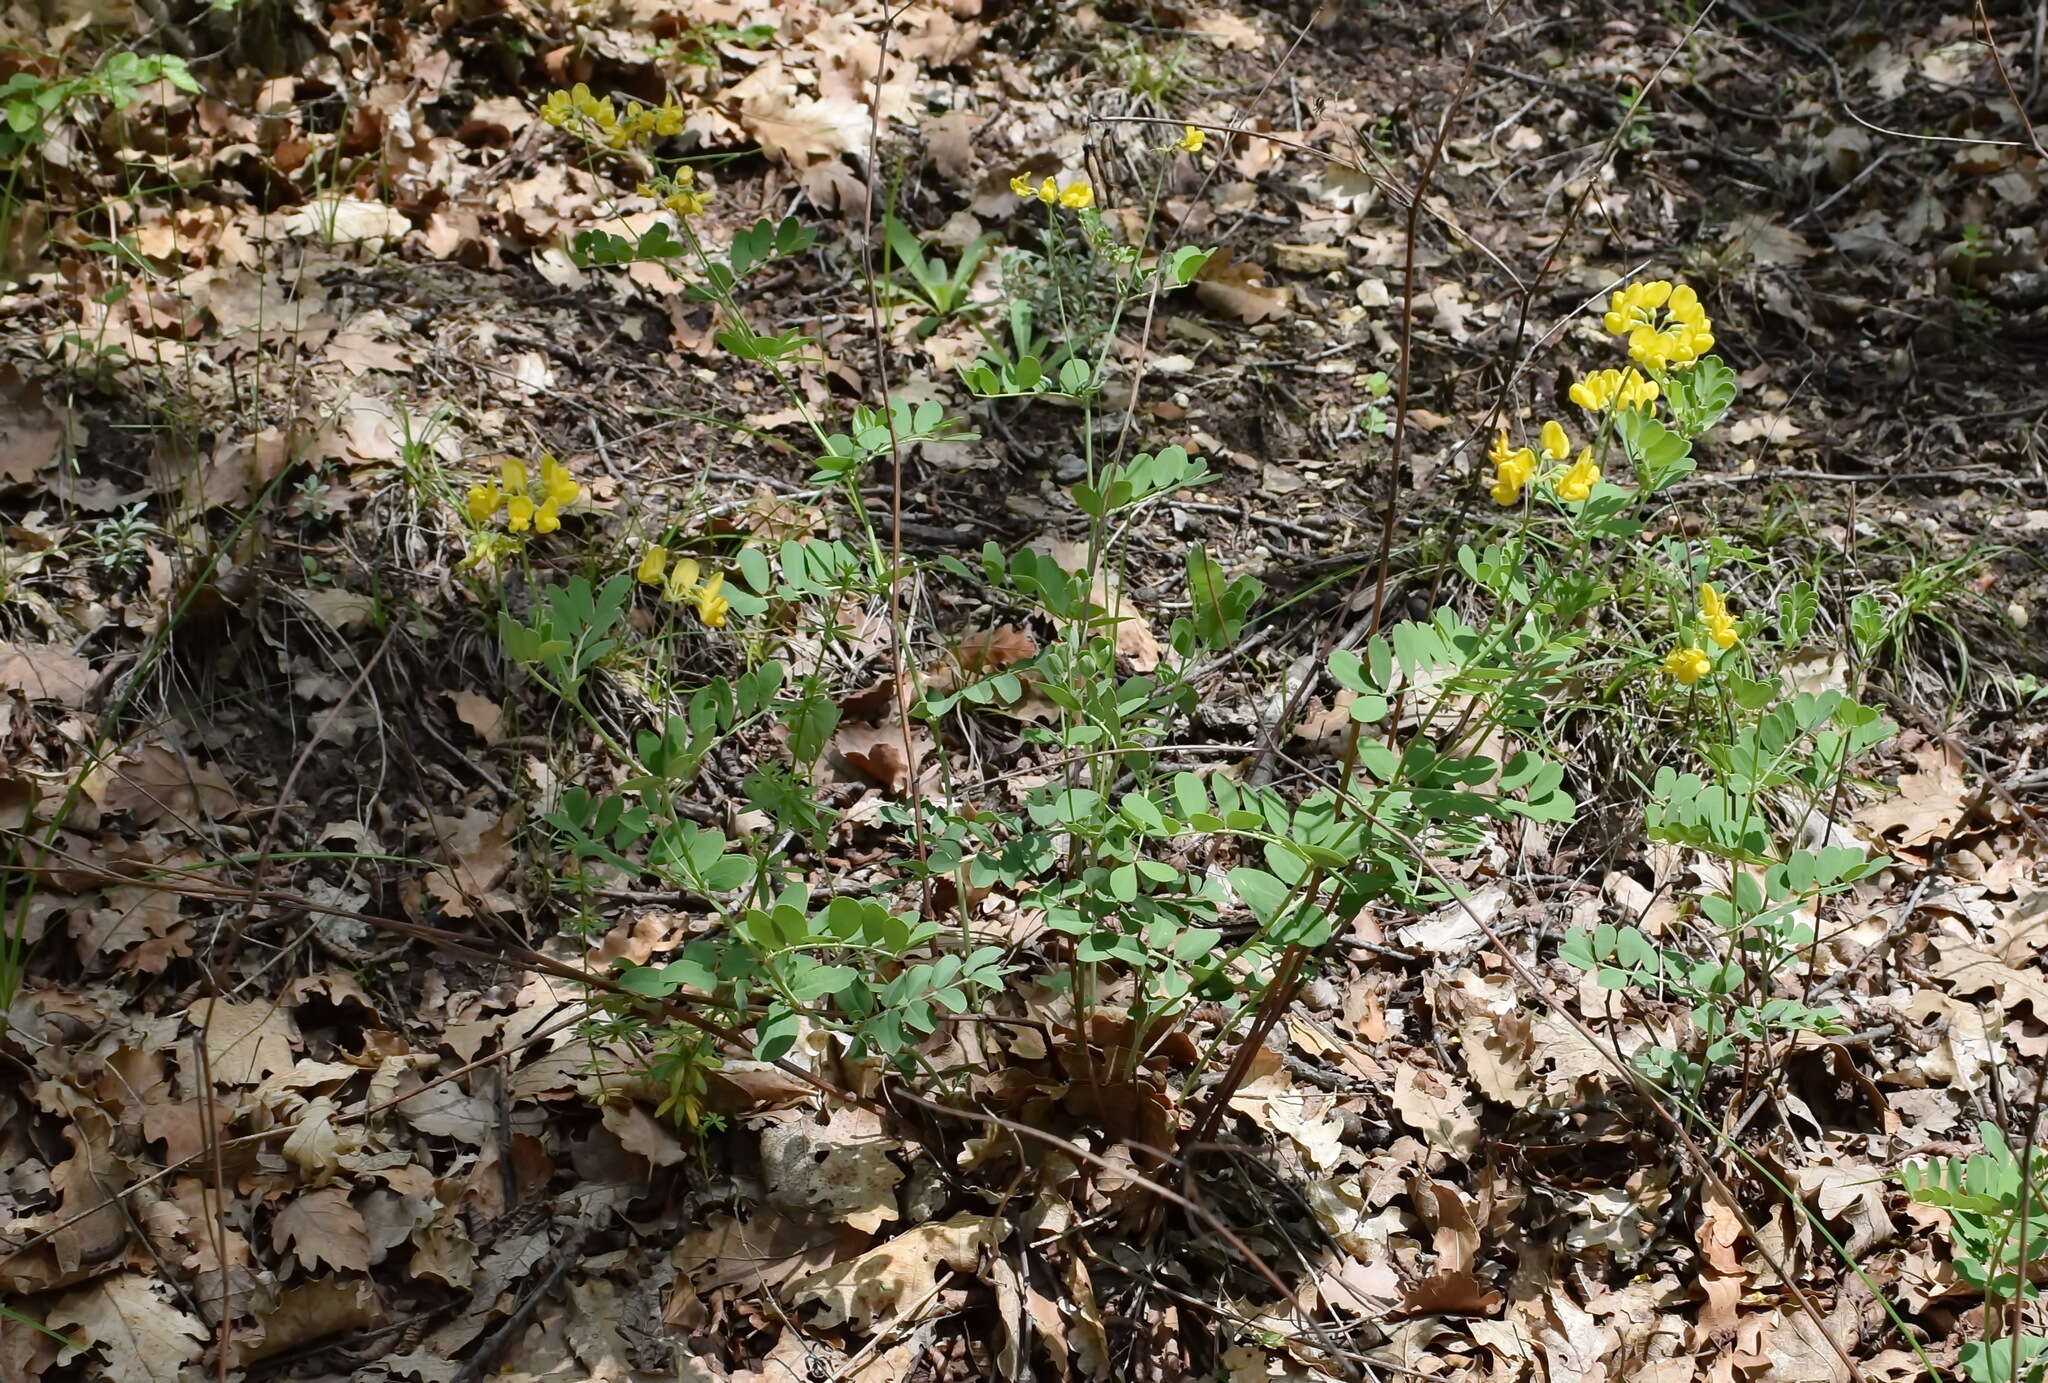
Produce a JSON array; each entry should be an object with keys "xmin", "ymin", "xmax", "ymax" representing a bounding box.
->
[{"xmin": 0, "ymin": 0, "xmax": 2048, "ymax": 1383}]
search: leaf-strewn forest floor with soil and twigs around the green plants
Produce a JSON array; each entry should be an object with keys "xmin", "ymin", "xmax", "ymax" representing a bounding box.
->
[{"xmin": 0, "ymin": 0, "xmax": 2048, "ymax": 1383}]
